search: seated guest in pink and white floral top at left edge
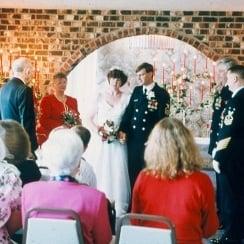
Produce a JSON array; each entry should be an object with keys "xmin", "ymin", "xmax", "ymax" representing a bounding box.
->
[{"xmin": 0, "ymin": 136, "xmax": 22, "ymax": 244}]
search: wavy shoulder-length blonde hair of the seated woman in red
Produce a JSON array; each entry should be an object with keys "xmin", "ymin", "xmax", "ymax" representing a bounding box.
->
[{"xmin": 145, "ymin": 118, "xmax": 202, "ymax": 179}]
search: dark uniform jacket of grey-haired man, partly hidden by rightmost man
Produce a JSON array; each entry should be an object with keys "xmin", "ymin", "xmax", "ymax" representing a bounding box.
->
[{"xmin": 208, "ymin": 86, "xmax": 232, "ymax": 155}]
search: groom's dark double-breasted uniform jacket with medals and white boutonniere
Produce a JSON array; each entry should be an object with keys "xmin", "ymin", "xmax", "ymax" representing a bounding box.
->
[{"xmin": 120, "ymin": 83, "xmax": 170, "ymax": 143}]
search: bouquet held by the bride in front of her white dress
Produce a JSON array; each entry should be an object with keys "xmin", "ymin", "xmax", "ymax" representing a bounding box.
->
[{"xmin": 98, "ymin": 120, "xmax": 118, "ymax": 143}]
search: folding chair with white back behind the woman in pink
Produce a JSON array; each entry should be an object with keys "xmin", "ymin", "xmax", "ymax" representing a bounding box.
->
[{"xmin": 23, "ymin": 208, "xmax": 84, "ymax": 244}]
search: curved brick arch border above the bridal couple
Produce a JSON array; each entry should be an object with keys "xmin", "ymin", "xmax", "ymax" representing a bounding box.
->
[{"xmin": 61, "ymin": 27, "xmax": 219, "ymax": 73}]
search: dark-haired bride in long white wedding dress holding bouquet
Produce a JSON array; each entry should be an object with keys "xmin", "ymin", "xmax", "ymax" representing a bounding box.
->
[{"xmin": 84, "ymin": 69, "xmax": 130, "ymax": 216}]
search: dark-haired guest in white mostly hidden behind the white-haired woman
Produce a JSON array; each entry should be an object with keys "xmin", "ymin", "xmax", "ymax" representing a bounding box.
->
[{"xmin": 72, "ymin": 125, "xmax": 97, "ymax": 188}]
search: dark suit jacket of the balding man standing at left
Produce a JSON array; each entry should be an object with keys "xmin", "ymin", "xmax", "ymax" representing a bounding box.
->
[{"xmin": 0, "ymin": 77, "xmax": 37, "ymax": 151}]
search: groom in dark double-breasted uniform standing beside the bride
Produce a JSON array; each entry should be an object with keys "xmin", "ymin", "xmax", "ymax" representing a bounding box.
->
[{"xmin": 119, "ymin": 63, "xmax": 170, "ymax": 189}]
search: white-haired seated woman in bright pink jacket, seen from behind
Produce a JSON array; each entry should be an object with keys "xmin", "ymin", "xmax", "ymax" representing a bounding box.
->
[{"xmin": 22, "ymin": 128, "xmax": 112, "ymax": 244}]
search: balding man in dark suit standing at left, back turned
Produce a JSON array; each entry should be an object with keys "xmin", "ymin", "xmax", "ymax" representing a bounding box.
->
[{"xmin": 0, "ymin": 57, "xmax": 37, "ymax": 152}]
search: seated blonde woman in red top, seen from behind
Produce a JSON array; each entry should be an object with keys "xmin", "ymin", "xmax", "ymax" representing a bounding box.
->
[{"xmin": 132, "ymin": 118, "xmax": 218, "ymax": 244}]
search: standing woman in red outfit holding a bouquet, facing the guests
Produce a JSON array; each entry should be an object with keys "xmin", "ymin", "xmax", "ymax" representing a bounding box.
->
[{"xmin": 37, "ymin": 73, "xmax": 80, "ymax": 145}]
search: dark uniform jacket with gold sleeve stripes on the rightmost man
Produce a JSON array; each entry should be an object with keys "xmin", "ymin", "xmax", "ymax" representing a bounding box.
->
[{"xmin": 214, "ymin": 88, "xmax": 244, "ymax": 191}]
